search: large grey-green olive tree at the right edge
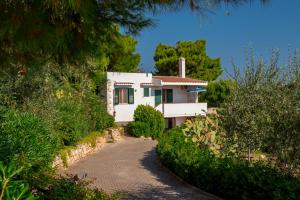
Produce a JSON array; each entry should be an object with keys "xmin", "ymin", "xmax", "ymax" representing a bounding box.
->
[{"xmin": 220, "ymin": 52, "xmax": 300, "ymax": 168}]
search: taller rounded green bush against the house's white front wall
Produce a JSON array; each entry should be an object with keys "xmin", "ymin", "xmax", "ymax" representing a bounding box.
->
[{"xmin": 134, "ymin": 105, "xmax": 165, "ymax": 138}]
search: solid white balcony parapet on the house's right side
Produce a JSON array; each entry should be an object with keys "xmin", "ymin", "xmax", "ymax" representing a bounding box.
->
[{"xmin": 156, "ymin": 103, "xmax": 207, "ymax": 117}]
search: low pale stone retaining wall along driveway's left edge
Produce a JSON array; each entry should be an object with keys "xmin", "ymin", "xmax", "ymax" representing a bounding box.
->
[{"xmin": 52, "ymin": 127, "xmax": 124, "ymax": 169}]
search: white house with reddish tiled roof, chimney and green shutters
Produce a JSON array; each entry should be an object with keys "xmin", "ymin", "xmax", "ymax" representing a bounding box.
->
[{"xmin": 107, "ymin": 58, "xmax": 207, "ymax": 128}]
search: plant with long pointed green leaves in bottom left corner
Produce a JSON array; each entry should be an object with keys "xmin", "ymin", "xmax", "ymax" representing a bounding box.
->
[{"xmin": 0, "ymin": 162, "xmax": 37, "ymax": 200}]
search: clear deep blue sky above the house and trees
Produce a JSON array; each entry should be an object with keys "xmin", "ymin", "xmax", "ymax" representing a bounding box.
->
[{"xmin": 136, "ymin": 0, "xmax": 300, "ymax": 78}]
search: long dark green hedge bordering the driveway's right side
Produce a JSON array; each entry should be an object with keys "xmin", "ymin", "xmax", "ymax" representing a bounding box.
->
[{"xmin": 157, "ymin": 128, "xmax": 300, "ymax": 200}]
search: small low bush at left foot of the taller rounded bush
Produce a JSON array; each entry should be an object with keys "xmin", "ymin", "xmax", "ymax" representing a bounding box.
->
[{"xmin": 126, "ymin": 121, "xmax": 151, "ymax": 137}]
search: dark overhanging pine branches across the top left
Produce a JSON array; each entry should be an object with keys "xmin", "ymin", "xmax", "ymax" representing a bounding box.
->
[{"xmin": 0, "ymin": 0, "xmax": 265, "ymax": 72}]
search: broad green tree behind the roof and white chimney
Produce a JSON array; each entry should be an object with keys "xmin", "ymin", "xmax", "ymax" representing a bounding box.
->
[{"xmin": 154, "ymin": 40, "xmax": 222, "ymax": 81}]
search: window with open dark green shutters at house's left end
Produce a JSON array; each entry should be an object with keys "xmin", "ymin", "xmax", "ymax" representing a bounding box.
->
[{"xmin": 114, "ymin": 88, "xmax": 134, "ymax": 105}]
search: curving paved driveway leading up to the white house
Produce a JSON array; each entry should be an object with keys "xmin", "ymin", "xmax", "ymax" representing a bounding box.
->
[{"xmin": 67, "ymin": 137, "xmax": 217, "ymax": 200}]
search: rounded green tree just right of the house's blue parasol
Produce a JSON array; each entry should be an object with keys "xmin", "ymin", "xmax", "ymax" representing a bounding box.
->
[{"xmin": 199, "ymin": 79, "xmax": 236, "ymax": 107}]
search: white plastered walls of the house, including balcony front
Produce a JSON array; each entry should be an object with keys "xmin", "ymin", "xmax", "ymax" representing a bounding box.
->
[{"xmin": 107, "ymin": 72, "xmax": 207, "ymax": 125}]
